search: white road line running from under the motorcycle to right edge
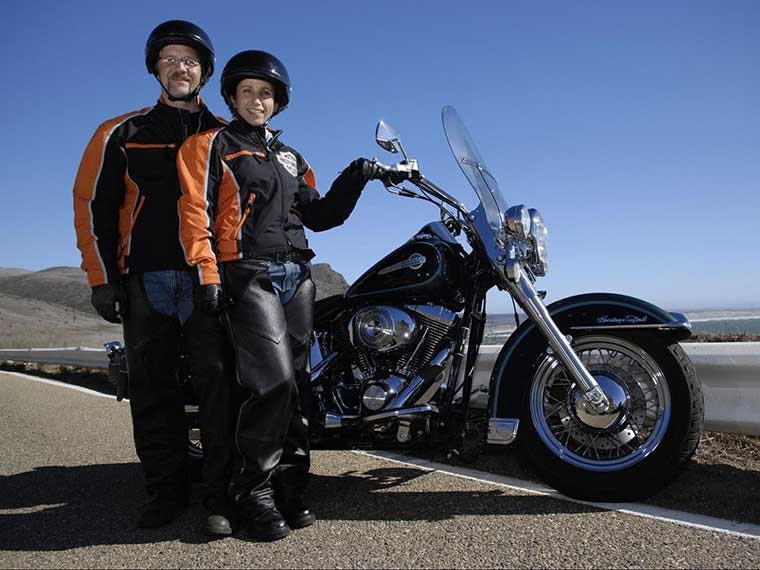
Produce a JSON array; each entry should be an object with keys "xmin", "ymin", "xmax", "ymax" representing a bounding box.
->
[{"xmin": 354, "ymin": 451, "xmax": 760, "ymax": 539}]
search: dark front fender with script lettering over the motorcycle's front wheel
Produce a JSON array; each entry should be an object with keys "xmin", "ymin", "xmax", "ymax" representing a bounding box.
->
[{"xmin": 489, "ymin": 293, "xmax": 691, "ymax": 418}]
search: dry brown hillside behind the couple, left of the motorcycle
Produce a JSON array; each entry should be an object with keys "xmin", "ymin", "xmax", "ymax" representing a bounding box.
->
[{"xmin": 0, "ymin": 263, "xmax": 348, "ymax": 348}]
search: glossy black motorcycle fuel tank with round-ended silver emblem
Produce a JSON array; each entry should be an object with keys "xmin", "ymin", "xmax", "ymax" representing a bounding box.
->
[{"xmin": 346, "ymin": 222, "xmax": 465, "ymax": 311}]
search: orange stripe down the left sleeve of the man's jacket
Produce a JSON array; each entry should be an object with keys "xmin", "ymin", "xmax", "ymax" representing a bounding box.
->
[{"xmin": 73, "ymin": 108, "xmax": 150, "ymax": 287}]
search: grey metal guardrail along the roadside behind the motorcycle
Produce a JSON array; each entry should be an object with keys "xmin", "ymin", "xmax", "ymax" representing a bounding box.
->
[{"xmin": 0, "ymin": 342, "xmax": 760, "ymax": 435}]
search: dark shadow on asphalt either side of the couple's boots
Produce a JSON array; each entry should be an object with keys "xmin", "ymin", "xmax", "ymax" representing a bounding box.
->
[{"xmin": 0, "ymin": 463, "xmax": 595, "ymax": 551}]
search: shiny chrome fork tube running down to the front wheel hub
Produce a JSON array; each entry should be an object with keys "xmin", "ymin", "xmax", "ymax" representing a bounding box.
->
[{"xmin": 505, "ymin": 264, "xmax": 611, "ymax": 414}]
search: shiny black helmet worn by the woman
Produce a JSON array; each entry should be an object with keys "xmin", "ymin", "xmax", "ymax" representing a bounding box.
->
[{"xmin": 222, "ymin": 50, "xmax": 290, "ymax": 115}]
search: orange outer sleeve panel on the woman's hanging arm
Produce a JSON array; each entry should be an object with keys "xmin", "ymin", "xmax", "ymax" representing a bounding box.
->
[{"xmin": 177, "ymin": 129, "xmax": 220, "ymax": 285}]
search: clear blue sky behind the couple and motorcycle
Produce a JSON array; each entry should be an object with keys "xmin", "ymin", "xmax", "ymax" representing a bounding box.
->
[{"xmin": 0, "ymin": 0, "xmax": 760, "ymax": 312}]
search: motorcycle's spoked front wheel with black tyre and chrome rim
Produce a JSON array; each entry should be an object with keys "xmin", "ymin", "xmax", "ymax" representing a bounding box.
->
[{"xmin": 519, "ymin": 333, "xmax": 704, "ymax": 501}]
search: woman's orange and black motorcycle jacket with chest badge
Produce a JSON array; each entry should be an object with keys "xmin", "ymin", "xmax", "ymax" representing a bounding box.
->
[{"xmin": 177, "ymin": 120, "xmax": 365, "ymax": 284}]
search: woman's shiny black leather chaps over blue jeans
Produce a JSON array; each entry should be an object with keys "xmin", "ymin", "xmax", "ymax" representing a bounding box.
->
[{"xmin": 224, "ymin": 259, "xmax": 315, "ymax": 502}]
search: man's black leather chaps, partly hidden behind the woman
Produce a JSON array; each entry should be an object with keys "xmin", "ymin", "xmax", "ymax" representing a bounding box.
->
[{"xmin": 124, "ymin": 275, "xmax": 235, "ymax": 500}]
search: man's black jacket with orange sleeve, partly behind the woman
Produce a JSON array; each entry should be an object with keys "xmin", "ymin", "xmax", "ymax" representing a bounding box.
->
[{"xmin": 74, "ymin": 101, "xmax": 226, "ymax": 287}]
